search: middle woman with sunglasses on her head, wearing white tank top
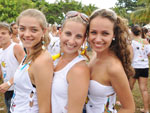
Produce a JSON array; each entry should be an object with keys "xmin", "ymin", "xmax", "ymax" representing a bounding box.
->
[{"xmin": 52, "ymin": 11, "xmax": 90, "ymax": 113}]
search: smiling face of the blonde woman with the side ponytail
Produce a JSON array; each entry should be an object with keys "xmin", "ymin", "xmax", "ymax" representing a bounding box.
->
[{"xmin": 19, "ymin": 16, "xmax": 44, "ymax": 49}]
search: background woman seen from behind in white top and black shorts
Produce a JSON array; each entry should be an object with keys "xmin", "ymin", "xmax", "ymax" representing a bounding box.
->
[{"xmin": 129, "ymin": 25, "xmax": 150, "ymax": 113}]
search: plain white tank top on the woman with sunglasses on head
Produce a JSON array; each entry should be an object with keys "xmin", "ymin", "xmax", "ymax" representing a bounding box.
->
[{"xmin": 52, "ymin": 56, "xmax": 85, "ymax": 113}]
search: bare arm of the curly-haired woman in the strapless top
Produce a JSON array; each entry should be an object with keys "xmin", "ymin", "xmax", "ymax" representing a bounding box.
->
[{"xmin": 109, "ymin": 63, "xmax": 135, "ymax": 113}]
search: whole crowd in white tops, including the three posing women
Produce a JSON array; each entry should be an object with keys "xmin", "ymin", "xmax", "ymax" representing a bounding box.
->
[{"xmin": 0, "ymin": 9, "xmax": 150, "ymax": 113}]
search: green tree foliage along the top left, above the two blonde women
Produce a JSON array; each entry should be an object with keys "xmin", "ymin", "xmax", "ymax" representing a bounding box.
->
[{"xmin": 0, "ymin": 0, "xmax": 96, "ymax": 24}]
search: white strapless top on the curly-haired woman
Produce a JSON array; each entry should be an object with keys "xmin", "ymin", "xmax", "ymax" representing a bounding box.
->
[{"xmin": 86, "ymin": 80, "xmax": 117, "ymax": 113}]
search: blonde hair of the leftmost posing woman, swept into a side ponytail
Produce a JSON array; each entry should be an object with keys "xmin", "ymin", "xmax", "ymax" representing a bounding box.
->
[{"xmin": 16, "ymin": 9, "xmax": 50, "ymax": 62}]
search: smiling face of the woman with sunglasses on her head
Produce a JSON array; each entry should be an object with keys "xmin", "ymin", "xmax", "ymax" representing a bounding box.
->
[{"xmin": 60, "ymin": 21, "xmax": 86, "ymax": 54}]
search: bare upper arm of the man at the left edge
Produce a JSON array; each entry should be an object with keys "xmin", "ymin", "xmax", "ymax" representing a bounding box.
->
[{"xmin": 14, "ymin": 45, "xmax": 25, "ymax": 64}]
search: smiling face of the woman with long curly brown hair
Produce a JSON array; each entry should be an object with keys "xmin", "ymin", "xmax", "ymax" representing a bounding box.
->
[{"xmin": 89, "ymin": 16, "xmax": 114, "ymax": 53}]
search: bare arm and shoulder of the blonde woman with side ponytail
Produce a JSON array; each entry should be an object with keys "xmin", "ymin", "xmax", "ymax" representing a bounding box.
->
[{"xmin": 31, "ymin": 52, "xmax": 53, "ymax": 113}]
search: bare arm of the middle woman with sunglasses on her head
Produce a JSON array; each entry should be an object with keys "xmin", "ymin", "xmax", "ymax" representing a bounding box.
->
[{"xmin": 67, "ymin": 62, "xmax": 90, "ymax": 113}]
